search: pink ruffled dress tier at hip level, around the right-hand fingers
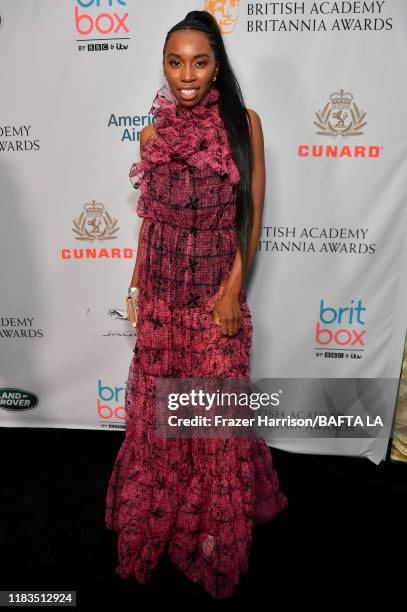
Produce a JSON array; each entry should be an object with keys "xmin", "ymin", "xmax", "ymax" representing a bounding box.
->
[{"xmin": 137, "ymin": 287, "xmax": 253, "ymax": 378}]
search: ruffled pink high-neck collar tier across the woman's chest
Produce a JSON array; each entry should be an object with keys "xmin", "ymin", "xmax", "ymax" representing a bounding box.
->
[{"xmin": 129, "ymin": 85, "xmax": 240, "ymax": 200}]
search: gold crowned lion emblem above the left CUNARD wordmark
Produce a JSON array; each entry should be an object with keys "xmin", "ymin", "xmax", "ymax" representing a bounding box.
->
[{"xmin": 72, "ymin": 200, "xmax": 120, "ymax": 242}]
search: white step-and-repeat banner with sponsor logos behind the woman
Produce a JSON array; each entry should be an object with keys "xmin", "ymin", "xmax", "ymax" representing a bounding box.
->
[{"xmin": 0, "ymin": 0, "xmax": 407, "ymax": 463}]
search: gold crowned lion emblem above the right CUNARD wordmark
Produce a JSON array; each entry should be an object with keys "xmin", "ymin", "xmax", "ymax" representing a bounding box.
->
[{"xmin": 314, "ymin": 89, "xmax": 367, "ymax": 138}]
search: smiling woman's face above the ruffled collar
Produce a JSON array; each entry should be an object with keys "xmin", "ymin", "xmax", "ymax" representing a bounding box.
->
[{"xmin": 163, "ymin": 30, "xmax": 218, "ymax": 111}]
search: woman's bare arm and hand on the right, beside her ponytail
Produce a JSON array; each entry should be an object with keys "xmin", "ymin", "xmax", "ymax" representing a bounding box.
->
[{"xmin": 214, "ymin": 109, "xmax": 266, "ymax": 336}]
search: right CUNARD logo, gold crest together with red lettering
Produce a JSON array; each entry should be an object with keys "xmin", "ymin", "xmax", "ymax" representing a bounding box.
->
[{"xmin": 297, "ymin": 89, "xmax": 383, "ymax": 159}]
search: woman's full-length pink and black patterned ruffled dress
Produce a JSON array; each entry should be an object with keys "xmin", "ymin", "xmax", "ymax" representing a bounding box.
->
[{"xmin": 106, "ymin": 85, "xmax": 288, "ymax": 598}]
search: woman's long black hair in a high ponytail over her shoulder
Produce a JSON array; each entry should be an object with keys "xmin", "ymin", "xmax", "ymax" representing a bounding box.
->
[{"xmin": 163, "ymin": 11, "xmax": 253, "ymax": 285}]
